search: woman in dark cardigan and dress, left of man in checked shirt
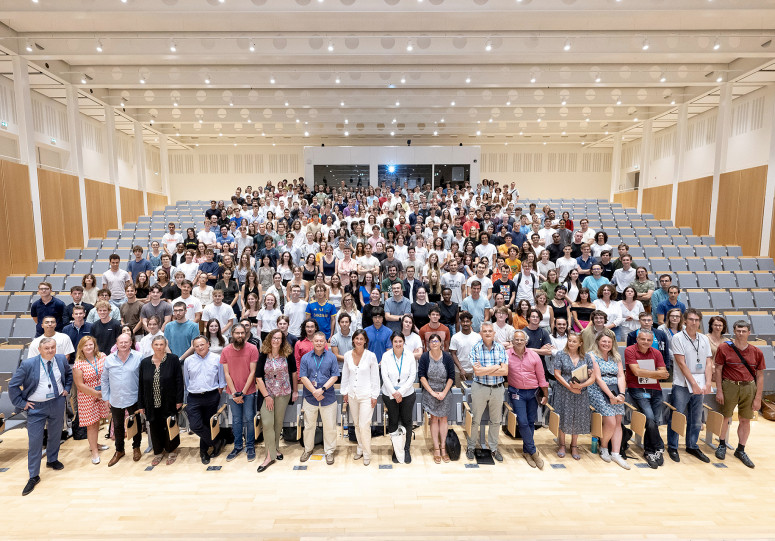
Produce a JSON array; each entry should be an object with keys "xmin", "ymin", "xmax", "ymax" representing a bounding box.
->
[{"xmin": 417, "ymin": 333, "xmax": 455, "ymax": 464}]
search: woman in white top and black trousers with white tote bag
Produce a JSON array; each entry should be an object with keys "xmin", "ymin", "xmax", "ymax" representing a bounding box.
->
[{"xmin": 380, "ymin": 333, "xmax": 418, "ymax": 464}]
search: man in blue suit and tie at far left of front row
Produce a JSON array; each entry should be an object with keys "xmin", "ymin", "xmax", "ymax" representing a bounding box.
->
[{"xmin": 8, "ymin": 337, "xmax": 73, "ymax": 496}]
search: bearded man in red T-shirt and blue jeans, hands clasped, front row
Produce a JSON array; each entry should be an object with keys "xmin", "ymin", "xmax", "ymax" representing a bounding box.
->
[{"xmin": 221, "ymin": 325, "xmax": 258, "ymax": 462}]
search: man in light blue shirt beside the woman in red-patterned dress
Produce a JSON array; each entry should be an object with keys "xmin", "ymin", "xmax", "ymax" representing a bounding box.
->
[{"xmin": 97, "ymin": 332, "xmax": 143, "ymax": 468}]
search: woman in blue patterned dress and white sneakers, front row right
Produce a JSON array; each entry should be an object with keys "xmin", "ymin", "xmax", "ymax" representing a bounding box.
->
[{"xmin": 586, "ymin": 333, "xmax": 630, "ymax": 470}]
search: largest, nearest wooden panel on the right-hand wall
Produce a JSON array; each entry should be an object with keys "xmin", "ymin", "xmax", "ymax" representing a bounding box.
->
[{"xmin": 716, "ymin": 165, "xmax": 767, "ymax": 256}]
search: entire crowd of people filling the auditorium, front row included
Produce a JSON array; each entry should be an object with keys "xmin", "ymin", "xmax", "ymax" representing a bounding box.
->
[{"xmin": 10, "ymin": 179, "xmax": 764, "ymax": 494}]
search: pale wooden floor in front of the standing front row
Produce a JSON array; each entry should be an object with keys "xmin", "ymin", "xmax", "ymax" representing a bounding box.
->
[{"xmin": 0, "ymin": 420, "xmax": 775, "ymax": 540}]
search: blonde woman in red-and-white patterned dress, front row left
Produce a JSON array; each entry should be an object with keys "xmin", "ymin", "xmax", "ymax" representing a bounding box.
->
[{"xmin": 73, "ymin": 336, "xmax": 110, "ymax": 464}]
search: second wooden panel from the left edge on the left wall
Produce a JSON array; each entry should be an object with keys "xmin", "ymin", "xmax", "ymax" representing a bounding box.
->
[{"xmin": 38, "ymin": 169, "xmax": 83, "ymax": 259}]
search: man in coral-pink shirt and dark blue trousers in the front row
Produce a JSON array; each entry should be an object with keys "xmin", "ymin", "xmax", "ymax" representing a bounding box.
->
[{"xmin": 510, "ymin": 330, "xmax": 549, "ymax": 470}]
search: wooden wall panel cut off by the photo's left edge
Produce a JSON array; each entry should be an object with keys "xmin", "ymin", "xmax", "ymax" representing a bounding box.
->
[{"xmin": 0, "ymin": 160, "xmax": 38, "ymax": 281}]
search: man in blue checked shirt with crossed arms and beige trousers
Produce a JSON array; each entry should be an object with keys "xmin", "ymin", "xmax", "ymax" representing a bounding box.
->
[{"xmin": 466, "ymin": 322, "xmax": 509, "ymax": 462}]
